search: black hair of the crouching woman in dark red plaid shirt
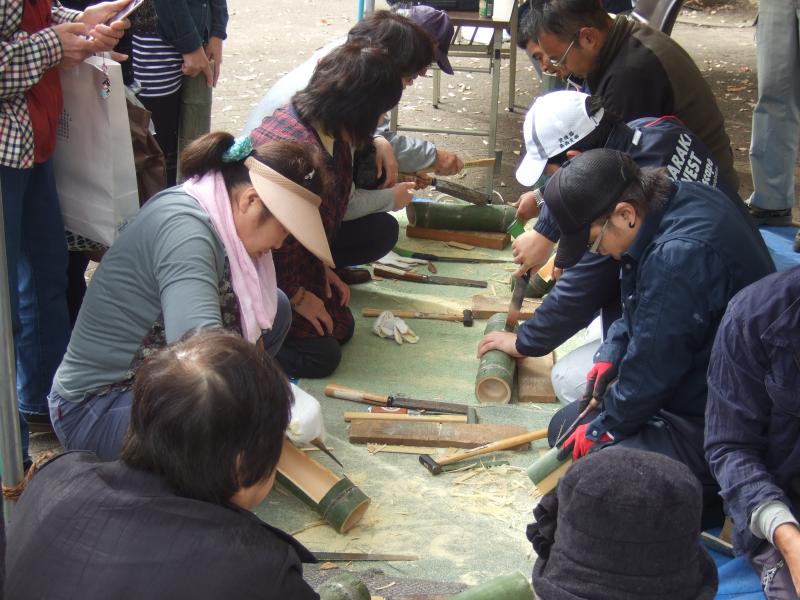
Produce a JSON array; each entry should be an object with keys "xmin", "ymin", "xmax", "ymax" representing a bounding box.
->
[{"xmin": 292, "ymin": 43, "xmax": 403, "ymax": 148}]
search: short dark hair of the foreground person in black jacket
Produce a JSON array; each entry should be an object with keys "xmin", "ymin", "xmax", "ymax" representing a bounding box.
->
[{"xmin": 120, "ymin": 329, "xmax": 293, "ymax": 504}]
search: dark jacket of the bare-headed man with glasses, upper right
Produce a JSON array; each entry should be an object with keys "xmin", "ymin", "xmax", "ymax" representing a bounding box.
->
[{"xmin": 586, "ymin": 17, "xmax": 739, "ymax": 191}]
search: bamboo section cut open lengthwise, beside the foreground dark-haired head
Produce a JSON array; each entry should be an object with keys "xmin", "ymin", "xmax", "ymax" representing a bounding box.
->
[{"xmin": 278, "ymin": 440, "xmax": 370, "ymax": 533}]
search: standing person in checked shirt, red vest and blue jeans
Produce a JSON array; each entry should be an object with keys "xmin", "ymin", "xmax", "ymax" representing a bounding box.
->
[{"xmin": 0, "ymin": 0, "xmax": 130, "ymax": 462}]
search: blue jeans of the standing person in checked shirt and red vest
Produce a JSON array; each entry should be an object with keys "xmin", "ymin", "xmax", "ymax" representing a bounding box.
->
[{"xmin": 0, "ymin": 160, "xmax": 70, "ymax": 456}]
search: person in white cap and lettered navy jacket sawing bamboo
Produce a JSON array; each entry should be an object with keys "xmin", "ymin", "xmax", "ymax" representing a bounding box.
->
[{"xmin": 484, "ymin": 91, "xmax": 760, "ymax": 402}]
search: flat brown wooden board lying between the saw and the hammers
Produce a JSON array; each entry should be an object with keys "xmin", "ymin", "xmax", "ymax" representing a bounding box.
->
[{"xmin": 350, "ymin": 421, "xmax": 528, "ymax": 450}]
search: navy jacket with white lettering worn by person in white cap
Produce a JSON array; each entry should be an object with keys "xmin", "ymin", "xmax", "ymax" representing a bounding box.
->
[{"xmin": 517, "ymin": 117, "xmax": 744, "ymax": 356}]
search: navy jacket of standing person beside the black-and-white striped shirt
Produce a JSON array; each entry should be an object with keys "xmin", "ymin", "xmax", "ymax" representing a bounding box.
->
[{"xmin": 153, "ymin": 0, "xmax": 228, "ymax": 54}]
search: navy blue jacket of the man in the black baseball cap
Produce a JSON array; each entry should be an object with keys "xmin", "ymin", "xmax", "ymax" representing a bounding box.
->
[{"xmin": 589, "ymin": 182, "xmax": 775, "ymax": 438}]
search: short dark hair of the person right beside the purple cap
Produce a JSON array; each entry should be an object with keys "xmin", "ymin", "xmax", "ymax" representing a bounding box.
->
[{"xmin": 347, "ymin": 10, "xmax": 435, "ymax": 77}]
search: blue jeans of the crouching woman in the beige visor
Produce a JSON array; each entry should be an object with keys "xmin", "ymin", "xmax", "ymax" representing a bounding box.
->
[{"xmin": 50, "ymin": 290, "xmax": 292, "ymax": 460}]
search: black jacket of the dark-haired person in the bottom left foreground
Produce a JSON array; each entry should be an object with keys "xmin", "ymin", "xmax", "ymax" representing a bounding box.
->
[{"xmin": 5, "ymin": 452, "xmax": 319, "ymax": 600}]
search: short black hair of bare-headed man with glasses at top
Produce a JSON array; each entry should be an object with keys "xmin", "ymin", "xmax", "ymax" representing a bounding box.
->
[{"xmin": 526, "ymin": 0, "xmax": 611, "ymax": 40}]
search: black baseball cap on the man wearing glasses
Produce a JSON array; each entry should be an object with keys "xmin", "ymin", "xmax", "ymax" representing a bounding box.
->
[{"xmin": 544, "ymin": 148, "xmax": 639, "ymax": 269}]
